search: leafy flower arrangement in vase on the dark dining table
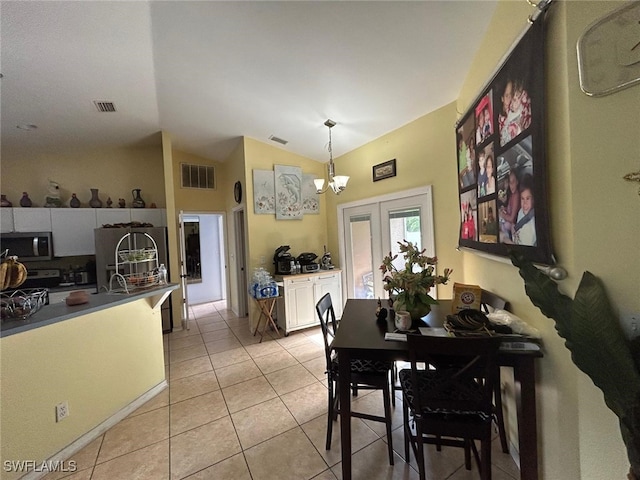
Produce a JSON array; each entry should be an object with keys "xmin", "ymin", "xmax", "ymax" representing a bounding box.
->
[{"xmin": 380, "ymin": 240, "xmax": 453, "ymax": 319}]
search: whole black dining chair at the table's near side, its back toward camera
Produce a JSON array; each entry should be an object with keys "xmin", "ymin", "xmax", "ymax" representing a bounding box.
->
[{"xmin": 399, "ymin": 334, "xmax": 500, "ymax": 480}]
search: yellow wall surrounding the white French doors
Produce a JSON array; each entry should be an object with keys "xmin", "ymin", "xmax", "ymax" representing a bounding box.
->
[{"xmin": 325, "ymin": 104, "xmax": 463, "ymax": 298}]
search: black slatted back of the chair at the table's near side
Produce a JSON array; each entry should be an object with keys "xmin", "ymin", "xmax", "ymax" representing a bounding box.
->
[{"xmin": 407, "ymin": 335, "xmax": 500, "ymax": 418}]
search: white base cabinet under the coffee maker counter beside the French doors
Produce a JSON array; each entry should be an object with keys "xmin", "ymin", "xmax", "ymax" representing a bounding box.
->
[{"xmin": 277, "ymin": 270, "xmax": 342, "ymax": 335}]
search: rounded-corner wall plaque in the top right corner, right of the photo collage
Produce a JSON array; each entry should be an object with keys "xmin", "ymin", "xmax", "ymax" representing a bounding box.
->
[{"xmin": 577, "ymin": 2, "xmax": 640, "ymax": 96}]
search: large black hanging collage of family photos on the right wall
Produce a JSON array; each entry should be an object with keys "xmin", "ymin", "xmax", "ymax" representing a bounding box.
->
[{"xmin": 456, "ymin": 15, "xmax": 553, "ymax": 264}]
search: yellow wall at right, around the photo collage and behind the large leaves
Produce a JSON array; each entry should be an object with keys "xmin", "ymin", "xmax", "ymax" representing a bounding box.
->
[{"xmin": 458, "ymin": 1, "xmax": 640, "ymax": 480}]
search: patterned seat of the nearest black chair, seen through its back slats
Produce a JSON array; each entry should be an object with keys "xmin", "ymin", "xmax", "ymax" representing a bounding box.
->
[{"xmin": 398, "ymin": 369, "xmax": 493, "ymax": 423}]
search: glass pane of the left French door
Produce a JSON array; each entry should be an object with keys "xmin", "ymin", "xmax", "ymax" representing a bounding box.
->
[{"xmin": 349, "ymin": 215, "xmax": 376, "ymax": 298}]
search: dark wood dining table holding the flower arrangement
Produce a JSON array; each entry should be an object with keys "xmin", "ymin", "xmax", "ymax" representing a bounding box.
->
[{"xmin": 332, "ymin": 299, "xmax": 542, "ymax": 480}]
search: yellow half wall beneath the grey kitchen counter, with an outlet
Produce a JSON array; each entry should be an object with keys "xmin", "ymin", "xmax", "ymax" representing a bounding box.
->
[{"xmin": 0, "ymin": 299, "xmax": 165, "ymax": 479}]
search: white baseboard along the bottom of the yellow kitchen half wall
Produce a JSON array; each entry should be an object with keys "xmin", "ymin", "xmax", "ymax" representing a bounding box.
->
[{"xmin": 20, "ymin": 380, "xmax": 169, "ymax": 480}]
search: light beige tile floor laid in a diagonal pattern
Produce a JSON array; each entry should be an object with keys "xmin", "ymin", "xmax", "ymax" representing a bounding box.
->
[{"xmin": 45, "ymin": 302, "xmax": 519, "ymax": 480}]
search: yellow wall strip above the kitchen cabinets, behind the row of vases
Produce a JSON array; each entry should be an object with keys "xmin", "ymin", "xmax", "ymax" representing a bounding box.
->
[{"xmin": 0, "ymin": 144, "xmax": 166, "ymax": 208}]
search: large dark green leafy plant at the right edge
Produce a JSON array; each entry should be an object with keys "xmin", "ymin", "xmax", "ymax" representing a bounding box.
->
[{"xmin": 511, "ymin": 252, "xmax": 640, "ymax": 479}]
